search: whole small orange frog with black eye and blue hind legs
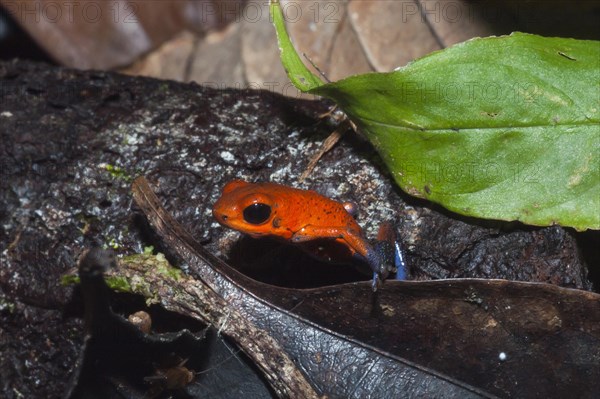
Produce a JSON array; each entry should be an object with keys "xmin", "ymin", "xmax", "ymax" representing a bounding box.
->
[{"xmin": 213, "ymin": 180, "xmax": 405, "ymax": 291}]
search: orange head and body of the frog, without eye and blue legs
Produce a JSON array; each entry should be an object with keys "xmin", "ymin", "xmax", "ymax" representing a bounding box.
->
[{"xmin": 213, "ymin": 180, "xmax": 372, "ymax": 263}]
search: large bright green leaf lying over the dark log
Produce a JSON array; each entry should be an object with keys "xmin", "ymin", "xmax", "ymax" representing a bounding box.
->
[{"xmin": 276, "ymin": 1, "xmax": 600, "ymax": 230}]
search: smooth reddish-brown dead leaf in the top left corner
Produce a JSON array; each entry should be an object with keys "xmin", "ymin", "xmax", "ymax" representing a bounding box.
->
[{"xmin": 0, "ymin": 0, "xmax": 233, "ymax": 70}]
